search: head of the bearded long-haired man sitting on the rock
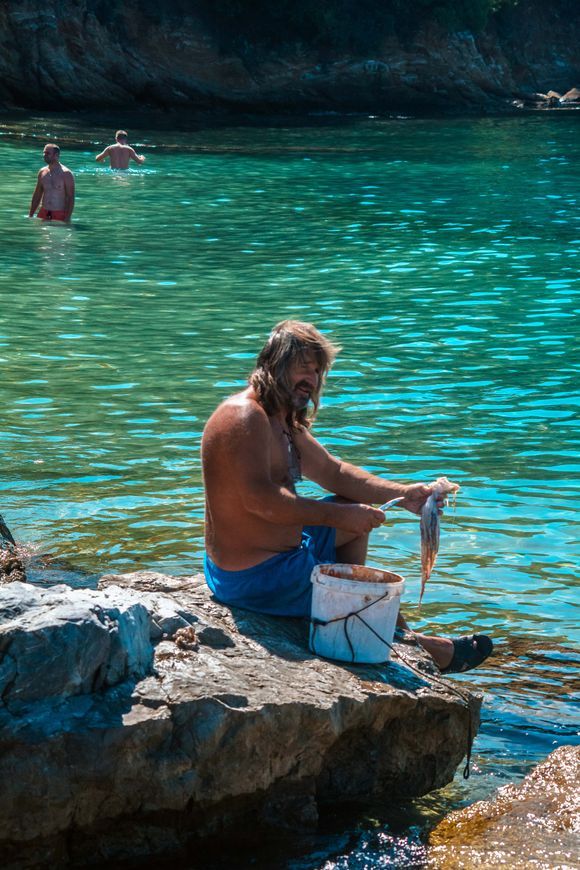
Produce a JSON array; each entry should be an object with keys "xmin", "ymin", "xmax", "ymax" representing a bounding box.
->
[{"xmin": 249, "ymin": 320, "xmax": 340, "ymax": 427}]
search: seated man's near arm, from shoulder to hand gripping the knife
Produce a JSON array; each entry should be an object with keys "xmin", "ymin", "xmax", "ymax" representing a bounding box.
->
[{"xmin": 202, "ymin": 404, "xmax": 385, "ymax": 534}]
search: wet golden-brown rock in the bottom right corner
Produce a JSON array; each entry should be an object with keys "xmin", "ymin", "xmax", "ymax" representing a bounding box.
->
[{"xmin": 427, "ymin": 746, "xmax": 580, "ymax": 870}]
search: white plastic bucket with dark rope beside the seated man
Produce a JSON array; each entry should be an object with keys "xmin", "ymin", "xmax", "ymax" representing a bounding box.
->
[{"xmin": 310, "ymin": 564, "xmax": 405, "ymax": 664}]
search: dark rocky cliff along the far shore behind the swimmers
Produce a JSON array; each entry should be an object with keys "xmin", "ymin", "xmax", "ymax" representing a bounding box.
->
[{"xmin": 0, "ymin": 0, "xmax": 580, "ymax": 112}]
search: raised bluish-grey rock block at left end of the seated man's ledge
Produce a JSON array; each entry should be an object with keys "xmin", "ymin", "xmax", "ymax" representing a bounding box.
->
[{"xmin": 0, "ymin": 583, "xmax": 153, "ymax": 716}]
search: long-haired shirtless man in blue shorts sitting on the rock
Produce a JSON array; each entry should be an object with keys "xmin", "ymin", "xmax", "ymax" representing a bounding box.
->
[{"xmin": 202, "ymin": 320, "xmax": 493, "ymax": 673}]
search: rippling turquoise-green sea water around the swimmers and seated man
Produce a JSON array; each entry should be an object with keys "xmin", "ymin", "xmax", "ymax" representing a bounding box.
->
[{"xmin": 0, "ymin": 113, "xmax": 580, "ymax": 870}]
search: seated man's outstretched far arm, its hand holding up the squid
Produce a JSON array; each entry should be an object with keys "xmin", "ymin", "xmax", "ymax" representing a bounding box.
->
[{"xmin": 296, "ymin": 429, "xmax": 431, "ymax": 513}]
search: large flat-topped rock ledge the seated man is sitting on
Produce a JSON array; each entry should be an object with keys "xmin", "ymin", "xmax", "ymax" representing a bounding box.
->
[{"xmin": 0, "ymin": 572, "xmax": 481, "ymax": 870}]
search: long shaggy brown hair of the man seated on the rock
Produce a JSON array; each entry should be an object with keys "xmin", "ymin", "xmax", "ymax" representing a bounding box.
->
[{"xmin": 249, "ymin": 320, "xmax": 340, "ymax": 428}]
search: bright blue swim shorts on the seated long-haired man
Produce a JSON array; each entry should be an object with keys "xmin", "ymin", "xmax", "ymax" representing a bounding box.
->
[{"xmin": 203, "ymin": 526, "xmax": 336, "ymax": 618}]
